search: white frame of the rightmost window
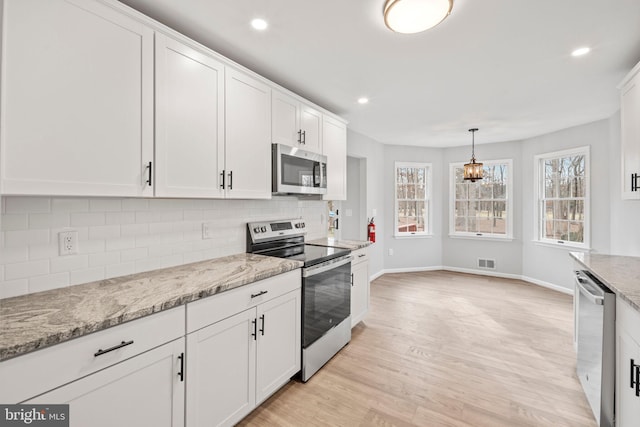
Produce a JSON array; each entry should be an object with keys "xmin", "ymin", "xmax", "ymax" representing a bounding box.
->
[{"xmin": 533, "ymin": 145, "xmax": 591, "ymax": 250}]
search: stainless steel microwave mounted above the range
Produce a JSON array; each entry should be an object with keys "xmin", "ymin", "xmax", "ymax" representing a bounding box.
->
[{"xmin": 271, "ymin": 144, "xmax": 327, "ymax": 194}]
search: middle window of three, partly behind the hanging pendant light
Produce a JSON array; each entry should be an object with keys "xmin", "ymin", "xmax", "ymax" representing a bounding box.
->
[{"xmin": 449, "ymin": 160, "xmax": 513, "ymax": 239}]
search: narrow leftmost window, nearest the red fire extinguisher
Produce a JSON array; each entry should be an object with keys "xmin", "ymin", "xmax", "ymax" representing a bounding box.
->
[{"xmin": 395, "ymin": 162, "xmax": 431, "ymax": 236}]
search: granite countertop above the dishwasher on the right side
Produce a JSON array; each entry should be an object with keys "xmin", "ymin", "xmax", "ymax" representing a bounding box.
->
[{"xmin": 571, "ymin": 252, "xmax": 640, "ymax": 311}]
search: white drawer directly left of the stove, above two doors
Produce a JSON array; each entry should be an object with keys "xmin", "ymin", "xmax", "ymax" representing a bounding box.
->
[{"xmin": 187, "ymin": 269, "xmax": 302, "ymax": 333}]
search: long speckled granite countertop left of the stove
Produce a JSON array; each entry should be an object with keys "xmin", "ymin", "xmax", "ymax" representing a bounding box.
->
[{"xmin": 0, "ymin": 254, "xmax": 302, "ymax": 361}]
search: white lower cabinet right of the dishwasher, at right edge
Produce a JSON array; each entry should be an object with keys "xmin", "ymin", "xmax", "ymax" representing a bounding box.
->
[{"xmin": 616, "ymin": 297, "xmax": 640, "ymax": 427}]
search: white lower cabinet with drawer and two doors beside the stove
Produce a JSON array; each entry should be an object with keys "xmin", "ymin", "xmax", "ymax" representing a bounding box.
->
[{"xmin": 186, "ymin": 270, "xmax": 301, "ymax": 427}]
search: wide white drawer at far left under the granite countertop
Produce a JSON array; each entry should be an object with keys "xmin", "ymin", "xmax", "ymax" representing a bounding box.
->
[{"xmin": 0, "ymin": 306, "xmax": 185, "ymax": 403}]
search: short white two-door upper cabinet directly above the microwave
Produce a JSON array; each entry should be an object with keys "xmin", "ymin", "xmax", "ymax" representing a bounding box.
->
[{"xmin": 271, "ymin": 90, "xmax": 322, "ymax": 153}]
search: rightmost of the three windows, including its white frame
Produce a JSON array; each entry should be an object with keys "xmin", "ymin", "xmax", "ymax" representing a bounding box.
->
[{"xmin": 535, "ymin": 147, "xmax": 589, "ymax": 247}]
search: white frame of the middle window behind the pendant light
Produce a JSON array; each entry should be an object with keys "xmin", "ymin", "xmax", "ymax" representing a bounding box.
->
[{"xmin": 449, "ymin": 159, "xmax": 515, "ymax": 241}]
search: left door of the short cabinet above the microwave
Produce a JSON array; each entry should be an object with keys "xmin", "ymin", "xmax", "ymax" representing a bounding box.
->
[{"xmin": 271, "ymin": 90, "xmax": 300, "ymax": 147}]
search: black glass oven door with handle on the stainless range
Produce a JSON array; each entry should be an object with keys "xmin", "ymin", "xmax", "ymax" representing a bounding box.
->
[{"xmin": 302, "ymin": 255, "xmax": 351, "ymax": 348}]
